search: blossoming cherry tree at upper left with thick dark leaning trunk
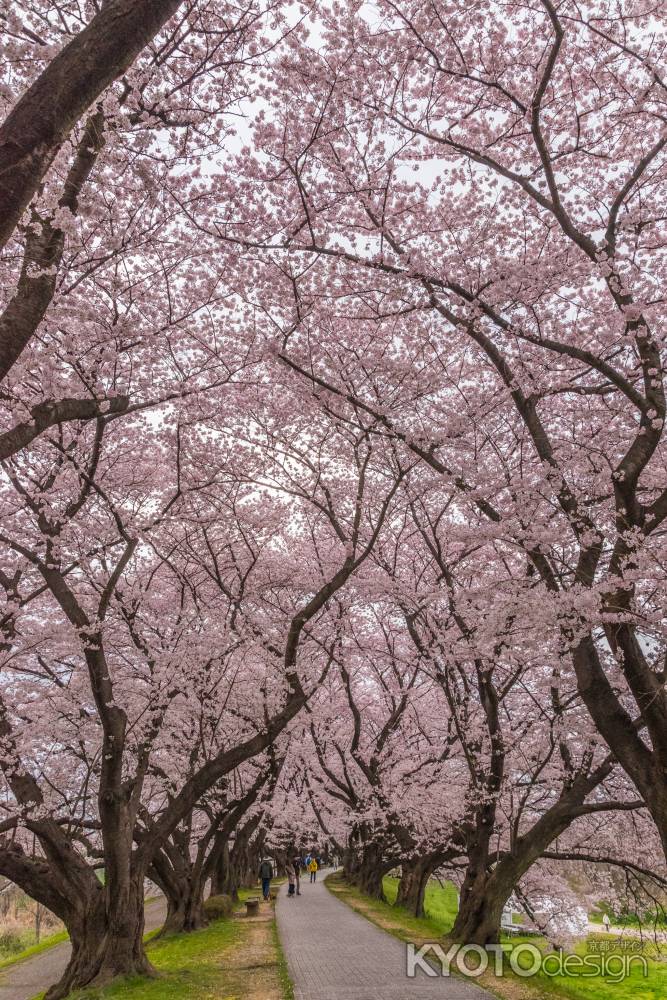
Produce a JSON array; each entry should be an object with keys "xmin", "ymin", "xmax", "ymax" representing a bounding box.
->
[{"xmin": 0, "ymin": 0, "xmax": 288, "ymax": 426}]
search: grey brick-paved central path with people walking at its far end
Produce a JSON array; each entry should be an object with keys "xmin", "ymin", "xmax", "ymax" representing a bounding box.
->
[{"xmin": 277, "ymin": 878, "xmax": 491, "ymax": 1000}]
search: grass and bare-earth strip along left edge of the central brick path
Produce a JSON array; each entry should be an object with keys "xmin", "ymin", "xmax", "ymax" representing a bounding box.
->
[{"xmin": 34, "ymin": 890, "xmax": 293, "ymax": 1000}]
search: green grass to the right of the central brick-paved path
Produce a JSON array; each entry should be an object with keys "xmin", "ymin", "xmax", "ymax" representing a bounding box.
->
[{"xmin": 325, "ymin": 875, "xmax": 667, "ymax": 1000}]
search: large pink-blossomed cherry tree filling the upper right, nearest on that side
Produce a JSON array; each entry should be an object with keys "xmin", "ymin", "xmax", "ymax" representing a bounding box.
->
[{"xmin": 213, "ymin": 0, "xmax": 667, "ymax": 860}]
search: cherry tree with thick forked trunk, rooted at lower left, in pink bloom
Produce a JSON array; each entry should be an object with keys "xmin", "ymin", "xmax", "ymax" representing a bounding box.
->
[{"xmin": 2, "ymin": 358, "xmax": 404, "ymax": 997}]
